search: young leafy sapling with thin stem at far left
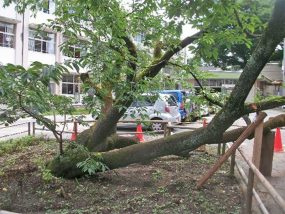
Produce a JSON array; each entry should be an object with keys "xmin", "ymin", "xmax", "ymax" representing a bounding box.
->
[{"xmin": 0, "ymin": 62, "xmax": 74, "ymax": 154}]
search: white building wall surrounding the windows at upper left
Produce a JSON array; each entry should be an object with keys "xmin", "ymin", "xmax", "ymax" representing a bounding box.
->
[{"xmin": 0, "ymin": 0, "xmax": 86, "ymax": 98}]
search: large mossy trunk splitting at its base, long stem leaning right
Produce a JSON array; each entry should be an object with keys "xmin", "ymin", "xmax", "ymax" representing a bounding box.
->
[{"xmin": 50, "ymin": 0, "xmax": 285, "ymax": 177}]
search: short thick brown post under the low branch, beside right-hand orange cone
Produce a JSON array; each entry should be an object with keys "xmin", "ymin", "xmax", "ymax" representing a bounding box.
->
[{"xmin": 259, "ymin": 132, "xmax": 275, "ymax": 176}]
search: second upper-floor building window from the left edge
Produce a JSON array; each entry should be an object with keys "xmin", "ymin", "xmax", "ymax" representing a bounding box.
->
[{"xmin": 29, "ymin": 30, "xmax": 55, "ymax": 54}]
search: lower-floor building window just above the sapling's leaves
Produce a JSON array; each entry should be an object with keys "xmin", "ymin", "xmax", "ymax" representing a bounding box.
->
[{"xmin": 61, "ymin": 75, "xmax": 80, "ymax": 95}]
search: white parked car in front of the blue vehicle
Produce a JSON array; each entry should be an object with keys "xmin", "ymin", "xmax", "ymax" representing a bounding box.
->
[{"xmin": 121, "ymin": 94, "xmax": 181, "ymax": 131}]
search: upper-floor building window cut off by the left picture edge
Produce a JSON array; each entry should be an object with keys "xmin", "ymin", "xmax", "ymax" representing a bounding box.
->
[{"xmin": 0, "ymin": 22, "xmax": 15, "ymax": 48}]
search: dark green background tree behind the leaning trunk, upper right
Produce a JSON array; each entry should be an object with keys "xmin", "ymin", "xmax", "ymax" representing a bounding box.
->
[{"xmin": 196, "ymin": 0, "xmax": 283, "ymax": 70}]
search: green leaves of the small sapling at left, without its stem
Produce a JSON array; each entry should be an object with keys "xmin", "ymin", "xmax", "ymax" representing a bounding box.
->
[{"xmin": 0, "ymin": 62, "xmax": 70, "ymax": 120}]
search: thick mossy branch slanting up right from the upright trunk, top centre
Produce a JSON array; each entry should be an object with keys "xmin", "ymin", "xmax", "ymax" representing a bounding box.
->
[{"xmin": 135, "ymin": 31, "xmax": 204, "ymax": 82}]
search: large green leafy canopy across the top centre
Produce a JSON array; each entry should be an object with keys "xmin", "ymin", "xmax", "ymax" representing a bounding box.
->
[{"xmin": 1, "ymin": 0, "xmax": 260, "ymax": 115}]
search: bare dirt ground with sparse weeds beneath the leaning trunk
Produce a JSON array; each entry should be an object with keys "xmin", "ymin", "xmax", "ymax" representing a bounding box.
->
[{"xmin": 0, "ymin": 139, "xmax": 242, "ymax": 213}]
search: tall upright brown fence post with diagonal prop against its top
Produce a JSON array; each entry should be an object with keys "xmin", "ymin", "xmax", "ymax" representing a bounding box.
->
[{"xmin": 245, "ymin": 119, "xmax": 263, "ymax": 213}]
